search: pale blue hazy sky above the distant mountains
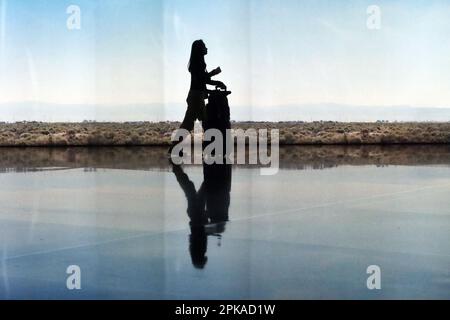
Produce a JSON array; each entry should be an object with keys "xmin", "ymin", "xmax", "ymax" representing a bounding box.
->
[{"xmin": 0, "ymin": 0, "xmax": 450, "ymax": 120}]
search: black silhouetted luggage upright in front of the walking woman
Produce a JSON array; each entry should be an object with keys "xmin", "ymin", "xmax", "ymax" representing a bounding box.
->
[{"xmin": 203, "ymin": 88, "xmax": 231, "ymax": 158}]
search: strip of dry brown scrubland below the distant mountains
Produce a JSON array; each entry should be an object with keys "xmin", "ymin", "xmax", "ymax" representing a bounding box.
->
[{"xmin": 0, "ymin": 122, "xmax": 450, "ymax": 146}]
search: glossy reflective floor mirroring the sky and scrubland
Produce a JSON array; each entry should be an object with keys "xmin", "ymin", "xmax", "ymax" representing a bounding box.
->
[{"xmin": 0, "ymin": 146, "xmax": 450, "ymax": 299}]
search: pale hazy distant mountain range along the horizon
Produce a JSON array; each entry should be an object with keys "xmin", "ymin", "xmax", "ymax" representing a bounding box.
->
[{"xmin": 0, "ymin": 102, "xmax": 450, "ymax": 122}]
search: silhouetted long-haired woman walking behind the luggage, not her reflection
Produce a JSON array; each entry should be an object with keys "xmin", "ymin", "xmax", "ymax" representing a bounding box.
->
[{"xmin": 169, "ymin": 40, "xmax": 226, "ymax": 152}]
